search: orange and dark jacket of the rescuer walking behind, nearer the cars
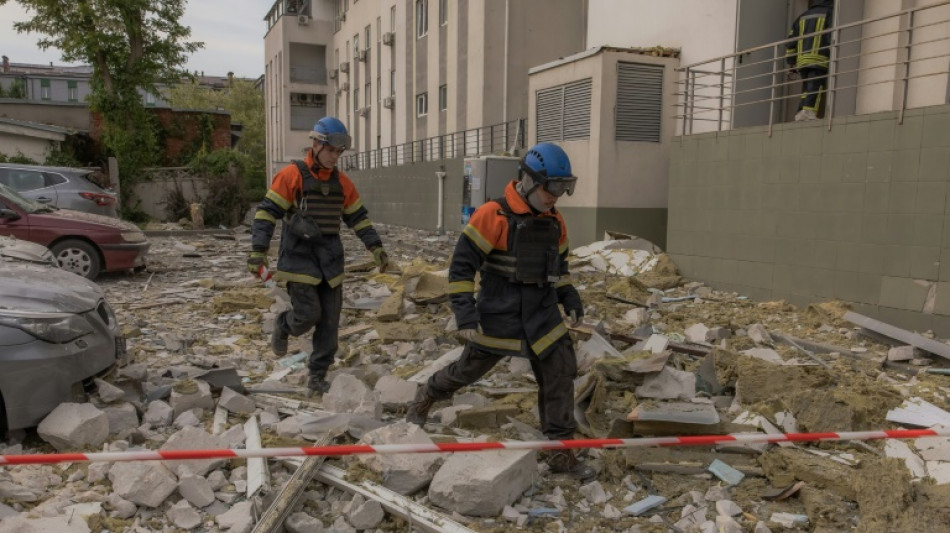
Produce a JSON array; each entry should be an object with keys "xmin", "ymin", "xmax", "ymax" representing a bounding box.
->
[{"xmin": 251, "ymin": 150, "xmax": 382, "ymax": 287}]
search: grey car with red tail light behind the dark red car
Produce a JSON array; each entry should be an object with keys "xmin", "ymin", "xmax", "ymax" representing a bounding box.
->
[{"xmin": 0, "ymin": 163, "xmax": 118, "ymax": 218}]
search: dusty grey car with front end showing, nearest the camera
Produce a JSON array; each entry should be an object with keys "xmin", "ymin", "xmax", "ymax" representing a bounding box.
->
[{"xmin": 0, "ymin": 237, "xmax": 125, "ymax": 435}]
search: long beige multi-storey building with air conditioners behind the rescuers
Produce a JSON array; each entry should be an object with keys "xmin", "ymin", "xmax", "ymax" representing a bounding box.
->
[{"xmin": 265, "ymin": 0, "xmax": 587, "ymax": 179}]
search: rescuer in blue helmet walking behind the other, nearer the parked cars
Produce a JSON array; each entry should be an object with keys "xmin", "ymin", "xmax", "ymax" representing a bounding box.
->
[{"xmin": 247, "ymin": 117, "xmax": 389, "ymax": 394}]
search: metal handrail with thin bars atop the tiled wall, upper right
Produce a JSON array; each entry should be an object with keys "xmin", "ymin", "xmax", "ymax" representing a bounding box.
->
[{"xmin": 674, "ymin": 0, "xmax": 950, "ymax": 135}]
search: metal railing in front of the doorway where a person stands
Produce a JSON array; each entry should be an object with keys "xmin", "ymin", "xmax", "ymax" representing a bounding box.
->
[{"xmin": 675, "ymin": 0, "xmax": 950, "ymax": 135}]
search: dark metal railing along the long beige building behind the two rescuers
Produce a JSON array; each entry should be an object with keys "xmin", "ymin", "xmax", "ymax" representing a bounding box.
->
[{"xmin": 340, "ymin": 118, "xmax": 526, "ymax": 170}]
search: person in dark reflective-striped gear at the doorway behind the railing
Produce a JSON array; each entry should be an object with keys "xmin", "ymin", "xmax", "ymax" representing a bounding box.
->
[{"xmin": 785, "ymin": 0, "xmax": 834, "ymax": 121}]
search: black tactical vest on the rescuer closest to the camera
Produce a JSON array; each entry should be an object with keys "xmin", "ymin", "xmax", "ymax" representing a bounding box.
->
[{"xmin": 482, "ymin": 198, "xmax": 561, "ymax": 285}]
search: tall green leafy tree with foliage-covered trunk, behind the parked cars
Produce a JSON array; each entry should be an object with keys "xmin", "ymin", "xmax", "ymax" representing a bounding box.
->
[{"xmin": 0, "ymin": 0, "xmax": 202, "ymax": 215}]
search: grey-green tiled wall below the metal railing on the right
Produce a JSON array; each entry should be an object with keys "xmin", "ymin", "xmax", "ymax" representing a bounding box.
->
[{"xmin": 668, "ymin": 105, "xmax": 950, "ymax": 336}]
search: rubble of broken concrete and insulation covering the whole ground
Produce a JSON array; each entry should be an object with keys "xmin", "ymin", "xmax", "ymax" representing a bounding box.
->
[{"xmin": 0, "ymin": 227, "xmax": 950, "ymax": 533}]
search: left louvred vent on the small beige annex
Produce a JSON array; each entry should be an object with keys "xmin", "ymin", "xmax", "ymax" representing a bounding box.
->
[{"xmin": 535, "ymin": 78, "xmax": 591, "ymax": 142}]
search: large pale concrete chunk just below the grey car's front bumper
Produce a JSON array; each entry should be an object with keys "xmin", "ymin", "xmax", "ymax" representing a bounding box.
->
[{"xmin": 36, "ymin": 403, "xmax": 109, "ymax": 452}]
